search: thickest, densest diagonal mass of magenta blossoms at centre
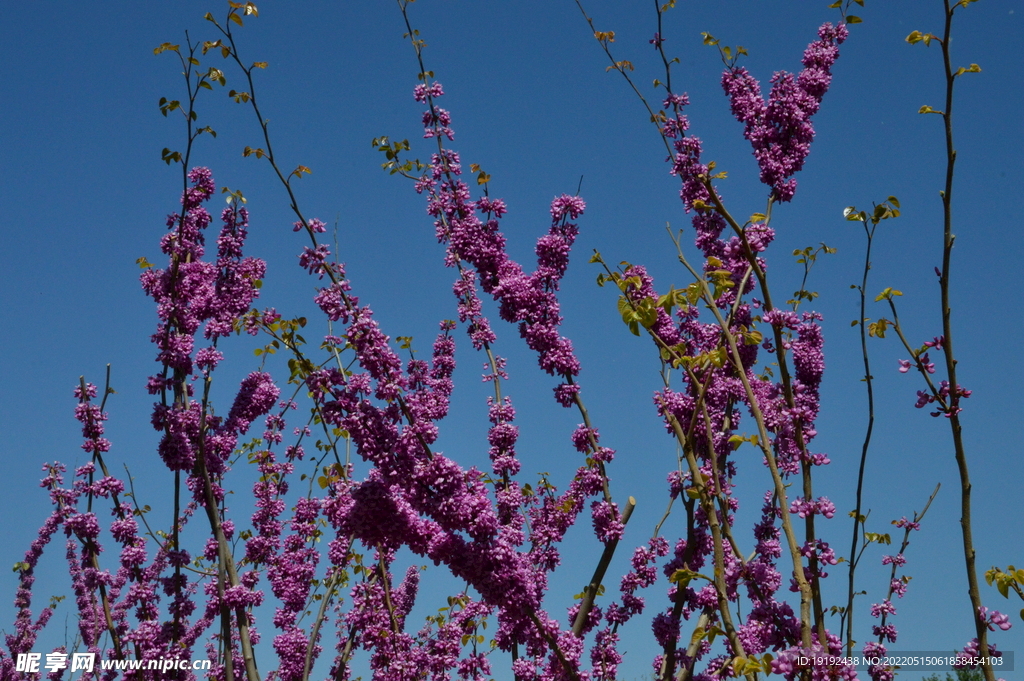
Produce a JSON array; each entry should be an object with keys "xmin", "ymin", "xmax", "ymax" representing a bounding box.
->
[{"xmin": 296, "ymin": 215, "xmax": 600, "ymax": 678}]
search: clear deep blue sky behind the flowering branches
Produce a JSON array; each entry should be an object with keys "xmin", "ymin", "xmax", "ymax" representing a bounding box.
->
[{"xmin": 0, "ymin": 0, "xmax": 1024, "ymax": 679}]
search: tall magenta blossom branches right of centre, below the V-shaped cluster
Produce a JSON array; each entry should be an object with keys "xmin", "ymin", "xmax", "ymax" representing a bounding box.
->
[{"xmin": 623, "ymin": 95, "xmax": 845, "ymax": 663}]
